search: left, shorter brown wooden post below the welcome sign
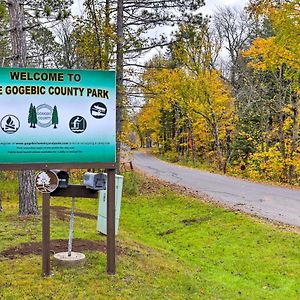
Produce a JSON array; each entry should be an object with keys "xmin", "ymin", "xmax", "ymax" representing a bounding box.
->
[{"xmin": 42, "ymin": 193, "xmax": 50, "ymax": 276}]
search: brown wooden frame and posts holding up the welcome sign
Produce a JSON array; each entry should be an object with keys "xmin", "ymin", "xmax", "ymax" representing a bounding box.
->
[{"xmin": 0, "ymin": 68, "xmax": 117, "ymax": 276}]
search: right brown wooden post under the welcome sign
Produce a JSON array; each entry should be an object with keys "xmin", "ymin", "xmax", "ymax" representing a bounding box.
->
[{"xmin": 106, "ymin": 169, "xmax": 116, "ymax": 275}]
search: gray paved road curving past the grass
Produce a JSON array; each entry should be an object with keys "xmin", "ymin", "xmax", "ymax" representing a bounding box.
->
[{"xmin": 133, "ymin": 152, "xmax": 300, "ymax": 226}]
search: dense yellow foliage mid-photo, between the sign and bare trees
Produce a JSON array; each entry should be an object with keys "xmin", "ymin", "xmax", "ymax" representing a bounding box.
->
[{"xmin": 139, "ymin": 59, "xmax": 235, "ymax": 162}]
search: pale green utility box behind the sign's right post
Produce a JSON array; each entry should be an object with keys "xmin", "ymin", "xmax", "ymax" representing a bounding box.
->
[{"xmin": 97, "ymin": 175, "xmax": 123, "ymax": 234}]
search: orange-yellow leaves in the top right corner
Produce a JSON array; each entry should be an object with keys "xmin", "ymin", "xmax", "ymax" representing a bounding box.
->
[{"xmin": 243, "ymin": 0, "xmax": 300, "ymax": 85}]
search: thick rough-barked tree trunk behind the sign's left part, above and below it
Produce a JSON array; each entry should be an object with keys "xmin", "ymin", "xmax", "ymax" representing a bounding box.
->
[{"xmin": 7, "ymin": 0, "xmax": 38, "ymax": 216}]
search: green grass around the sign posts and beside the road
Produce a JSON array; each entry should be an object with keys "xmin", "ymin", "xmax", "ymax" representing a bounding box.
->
[{"xmin": 0, "ymin": 174, "xmax": 300, "ymax": 300}]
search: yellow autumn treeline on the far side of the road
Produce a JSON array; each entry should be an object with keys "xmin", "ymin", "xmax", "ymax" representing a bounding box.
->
[{"xmin": 131, "ymin": 0, "xmax": 300, "ymax": 183}]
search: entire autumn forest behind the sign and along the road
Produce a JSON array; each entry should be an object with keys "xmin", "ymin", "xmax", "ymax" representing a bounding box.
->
[{"xmin": 0, "ymin": 0, "xmax": 300, "ymax": 216}]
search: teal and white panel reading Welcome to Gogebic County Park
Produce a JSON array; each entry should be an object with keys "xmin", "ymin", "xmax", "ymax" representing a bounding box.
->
[{"xmin": 0, "ymin": 68, "xmax": 116, "ymax": 164}]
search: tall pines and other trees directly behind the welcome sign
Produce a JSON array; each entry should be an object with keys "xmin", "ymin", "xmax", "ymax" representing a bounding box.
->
[{"xmin": 0, "ymin": 0, "xmax": 203, "ymax": 215}]
